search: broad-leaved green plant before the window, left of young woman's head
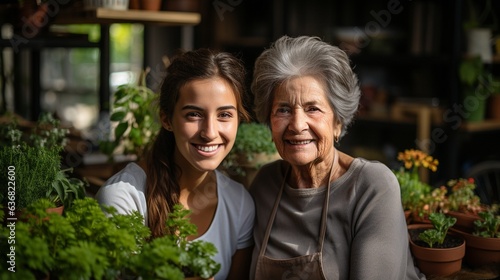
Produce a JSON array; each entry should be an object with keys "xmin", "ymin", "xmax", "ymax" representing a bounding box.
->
[{"xmin": 99, "ymin": 80, "xmax": 159, "ymax": 160}]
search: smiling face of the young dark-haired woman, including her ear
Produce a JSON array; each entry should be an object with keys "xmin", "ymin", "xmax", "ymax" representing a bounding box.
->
[{"xmin": 162, "ymin": 77, "xmax": 238, "ymax": 171}]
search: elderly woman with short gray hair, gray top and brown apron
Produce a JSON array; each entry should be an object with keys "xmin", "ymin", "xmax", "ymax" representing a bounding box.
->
[{"xmin": 250, "ymin": 36, "xmax": 425, "ymax": 280}]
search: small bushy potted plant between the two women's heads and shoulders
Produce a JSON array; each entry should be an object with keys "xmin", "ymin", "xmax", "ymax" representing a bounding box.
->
[{"xmin": 222, "ymin": 122, "xmax": 280, "ymax": 187}]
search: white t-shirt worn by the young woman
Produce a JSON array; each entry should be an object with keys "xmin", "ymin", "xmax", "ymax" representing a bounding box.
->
[{"xmin": 96, "ymin": 163, "xmax": 255, "ymax": 280}]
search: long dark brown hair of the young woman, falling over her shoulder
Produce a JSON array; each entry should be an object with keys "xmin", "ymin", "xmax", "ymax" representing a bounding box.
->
[{"xmin": 146, "ymin": 49, "xmax": 250, "ymax": 238}]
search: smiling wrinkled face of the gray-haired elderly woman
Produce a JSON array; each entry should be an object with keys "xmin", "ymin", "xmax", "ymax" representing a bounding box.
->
[{"xmin": 270, "ymin": 76, "xmax": 341, "ymax": 165}]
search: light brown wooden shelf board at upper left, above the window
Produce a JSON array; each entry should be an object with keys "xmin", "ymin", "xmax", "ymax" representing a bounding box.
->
[{"xmin": 53, "ymin": 8, "xmax": 201, "ymax": 25}]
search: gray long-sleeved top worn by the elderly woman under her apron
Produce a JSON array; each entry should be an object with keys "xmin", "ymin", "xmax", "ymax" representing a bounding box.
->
[{"xmin": 250, "ymin": 158, "xmax": 425, "ymax": 280}]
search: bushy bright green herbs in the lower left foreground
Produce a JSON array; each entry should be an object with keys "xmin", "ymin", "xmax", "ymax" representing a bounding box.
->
[{"xmin": 0, "ymin": 198, "xmax": 220, "ymax": 280}]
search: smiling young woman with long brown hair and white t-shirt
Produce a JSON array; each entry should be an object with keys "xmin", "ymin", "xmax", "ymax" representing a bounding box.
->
[{"xmin": 96, "ymin": 49, "xmax": 255, "ymax": 279}]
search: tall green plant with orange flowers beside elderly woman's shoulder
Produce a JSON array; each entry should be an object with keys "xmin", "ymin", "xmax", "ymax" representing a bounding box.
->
[{"xmin": 393, "ymin": 149, "xmax": 439, "ymax": 223}]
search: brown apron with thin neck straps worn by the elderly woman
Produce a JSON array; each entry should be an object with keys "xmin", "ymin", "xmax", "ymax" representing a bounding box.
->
[{"xmin": 255, "ymin": 153, "xmax": 337, "ymax": 280}]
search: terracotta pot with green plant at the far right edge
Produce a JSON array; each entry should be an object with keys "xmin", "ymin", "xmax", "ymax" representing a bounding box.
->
[{"xmin": 452, "ymin": 210, "xmax": 500, "ymax": 267}]
